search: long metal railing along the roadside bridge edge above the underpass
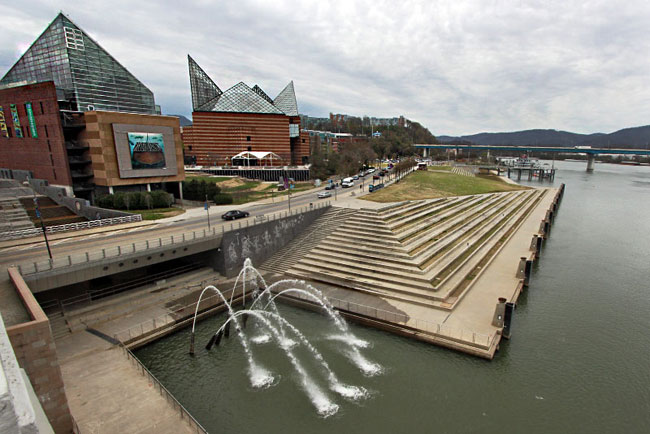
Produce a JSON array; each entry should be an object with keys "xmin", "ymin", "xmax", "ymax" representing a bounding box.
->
[{"xmin": 18, "ymin": 202, "xmax": 330, "ymax": 276}]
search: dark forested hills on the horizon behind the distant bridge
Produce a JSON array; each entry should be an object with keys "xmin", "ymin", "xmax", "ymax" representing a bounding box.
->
[{"xmin": 438, "ymin": 125, "xmax": 650, "ymax": 148}]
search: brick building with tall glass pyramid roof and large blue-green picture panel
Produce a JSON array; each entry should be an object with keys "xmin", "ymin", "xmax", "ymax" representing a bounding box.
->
[{"xmin": 0, "ymin": 13, "xmax": 185, "ymax": 201}]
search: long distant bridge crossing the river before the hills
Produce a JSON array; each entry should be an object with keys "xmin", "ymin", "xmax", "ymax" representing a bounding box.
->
[{"xmin": 415, "ymin": 143, "xmax": 650, "ymax": 172}]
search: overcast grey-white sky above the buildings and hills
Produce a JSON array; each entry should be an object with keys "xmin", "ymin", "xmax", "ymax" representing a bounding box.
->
[{"xmin": 0, "ymin": 0, "xmax": 650, "ymax": 135}]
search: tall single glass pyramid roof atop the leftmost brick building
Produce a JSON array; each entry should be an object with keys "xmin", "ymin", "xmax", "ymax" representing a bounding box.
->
[{"xmin": 0, "ymin": 13, "xmax": 159, "ymax": 114}]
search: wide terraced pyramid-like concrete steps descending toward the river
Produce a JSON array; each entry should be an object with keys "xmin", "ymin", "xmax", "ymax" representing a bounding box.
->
[{"xmin": 287, "ymin": 190, "xmax": 546, "ymax": 309}]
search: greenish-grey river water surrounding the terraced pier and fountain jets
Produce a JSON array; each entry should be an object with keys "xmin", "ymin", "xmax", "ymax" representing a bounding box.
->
[{"xmin": 136, "ymin": 162, "xmax": 650, "ymax": 433}]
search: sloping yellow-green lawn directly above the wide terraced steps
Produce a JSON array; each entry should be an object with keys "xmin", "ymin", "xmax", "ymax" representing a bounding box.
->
[{"xmin": 360, "ymin": 170, "xmax": 526, "ymax": 202}]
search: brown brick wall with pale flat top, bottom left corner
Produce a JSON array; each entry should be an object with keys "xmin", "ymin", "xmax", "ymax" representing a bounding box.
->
[{"xmin": 7, "ymin": 268, "xmax": 72, "ymax": 433}]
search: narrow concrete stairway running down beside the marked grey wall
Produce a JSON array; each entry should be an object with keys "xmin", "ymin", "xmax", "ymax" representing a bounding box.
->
[{"xmin": 258, "ymin": 206, "xmax": 357, "ymax": 274}]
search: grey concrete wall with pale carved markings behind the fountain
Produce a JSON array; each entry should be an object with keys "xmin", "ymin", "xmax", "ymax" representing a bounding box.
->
[{"xmin": 212, "ymin": 207, "xmax": 328, "ymax": 277}]
